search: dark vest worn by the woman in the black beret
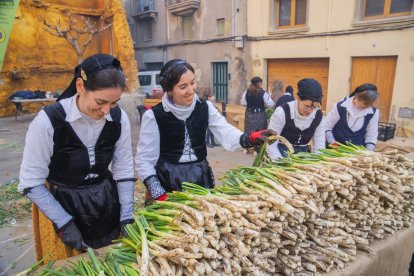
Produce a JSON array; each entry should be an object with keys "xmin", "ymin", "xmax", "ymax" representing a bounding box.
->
[{"xmin": 280, "ymin": 103, "xmax": 323, "ymax": 145}]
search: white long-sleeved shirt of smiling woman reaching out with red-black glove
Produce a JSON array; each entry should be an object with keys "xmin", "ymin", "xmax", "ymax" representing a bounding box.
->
[{"xmin": 135, "ymin": 101, "xmax": 243, "ymax": 180}]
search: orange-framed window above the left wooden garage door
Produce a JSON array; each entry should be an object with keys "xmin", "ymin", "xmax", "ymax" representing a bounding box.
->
[{"xmin": 275, "ymin": 0, "xmax": 307, "ymax": 28}]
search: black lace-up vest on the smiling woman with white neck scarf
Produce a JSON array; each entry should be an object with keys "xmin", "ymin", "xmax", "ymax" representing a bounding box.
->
[{"xmin": 152, "ymin": 100, "xmax": 208, "ymax": 164}]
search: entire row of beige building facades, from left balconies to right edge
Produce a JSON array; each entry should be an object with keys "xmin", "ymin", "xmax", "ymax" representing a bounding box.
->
[{"xmin": 127, "ymin": 0, "xmax": 414, "ymax": 137}]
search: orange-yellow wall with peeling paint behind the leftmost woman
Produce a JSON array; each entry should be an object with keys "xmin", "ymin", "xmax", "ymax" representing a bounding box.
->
[{"xmin": 0, "ymin": 0, "xmax": 138, "ymax": 117}]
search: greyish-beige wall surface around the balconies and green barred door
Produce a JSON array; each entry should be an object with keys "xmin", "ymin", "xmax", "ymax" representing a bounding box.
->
[{"xmin": 130, "ymin": 0, "xmax": 250, "ymax": 103}]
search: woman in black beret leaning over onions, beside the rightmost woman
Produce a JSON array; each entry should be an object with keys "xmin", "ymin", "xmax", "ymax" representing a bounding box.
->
[{"xmin": 267, "ymin": 78, "xmax": 325, "ymax": 160}]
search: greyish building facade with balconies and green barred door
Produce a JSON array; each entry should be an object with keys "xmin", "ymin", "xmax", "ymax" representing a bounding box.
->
[{"xmin": 125, "ymin": 0, "xmax": 250, "ymax": 102}]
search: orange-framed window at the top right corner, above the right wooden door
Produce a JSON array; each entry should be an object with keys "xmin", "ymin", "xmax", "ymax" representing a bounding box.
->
[{"xmin": 362, "ymin": 0, "xmax": 413, "ymax": 19}]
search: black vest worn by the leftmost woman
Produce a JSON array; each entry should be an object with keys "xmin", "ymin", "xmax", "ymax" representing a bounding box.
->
[{"xmin": 44, "ymin": 103, "xmax": 121, "ymax": 188}]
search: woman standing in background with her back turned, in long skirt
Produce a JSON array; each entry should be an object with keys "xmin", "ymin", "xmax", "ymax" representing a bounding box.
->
[{"xmin": 240, "ymin": 77, "xmax": 274, "ymax": 133}]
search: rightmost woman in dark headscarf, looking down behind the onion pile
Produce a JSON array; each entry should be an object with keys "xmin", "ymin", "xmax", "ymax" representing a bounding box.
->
[{"xmin": 326, "ymin": 83, "xmax": 379, "ymax": 151}]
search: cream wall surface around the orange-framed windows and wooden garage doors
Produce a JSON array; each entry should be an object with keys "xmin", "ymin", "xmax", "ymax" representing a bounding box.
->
[{"xmin": 247, "ymin": 0, "xmax": 414, "ymax": 135}]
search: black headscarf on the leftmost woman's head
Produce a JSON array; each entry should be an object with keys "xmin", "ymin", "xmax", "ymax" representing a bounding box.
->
[{"xmin": 57, "ymin": 54, "xmax": 123, "ymax": 101}]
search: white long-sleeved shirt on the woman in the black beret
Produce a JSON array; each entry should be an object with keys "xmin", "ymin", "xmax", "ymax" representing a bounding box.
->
[{"xmin": 267, "ymin": 100, "xmax": 325, "ymax": 159}]
